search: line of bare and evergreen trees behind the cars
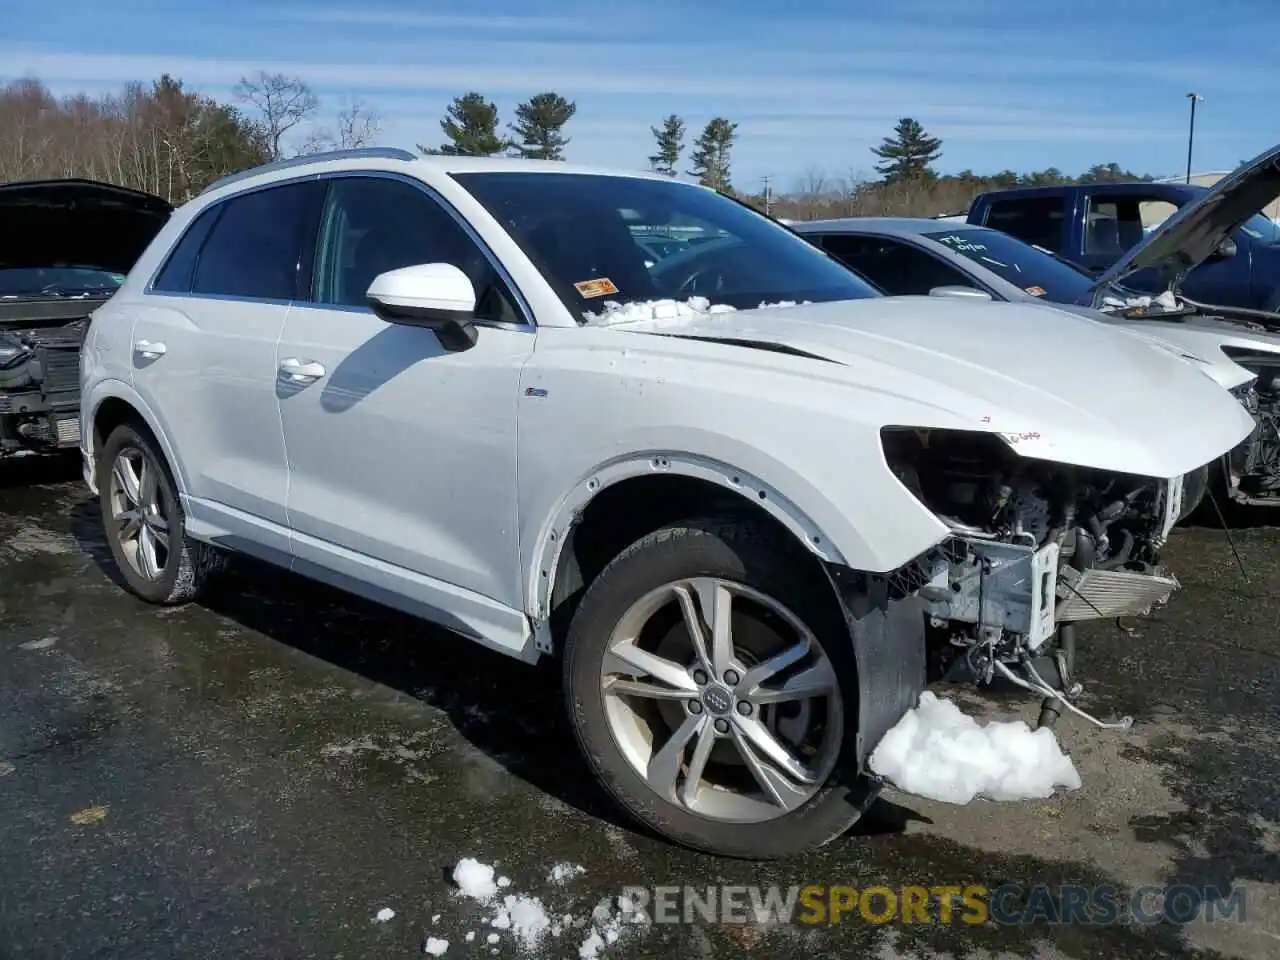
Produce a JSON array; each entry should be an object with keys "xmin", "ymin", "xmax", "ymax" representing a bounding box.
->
[{"xmin": 0, "ymin": 72, "xmax": 1151, "ymax": 219}]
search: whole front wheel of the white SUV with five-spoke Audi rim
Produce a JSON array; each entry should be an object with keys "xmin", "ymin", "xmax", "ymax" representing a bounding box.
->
[{"xmin": 564, "ymin": 520, "xmax": 878, "ymax": 860}]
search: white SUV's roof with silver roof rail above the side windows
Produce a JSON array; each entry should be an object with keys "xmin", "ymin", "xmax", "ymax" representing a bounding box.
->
[{"xmin": 201, "ymin": 147, "xmax": 692, "ymax": 196}]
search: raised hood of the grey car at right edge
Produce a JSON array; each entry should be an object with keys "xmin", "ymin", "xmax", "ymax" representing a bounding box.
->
[{"xmin": 1094, "ymin": 145, "xmax": 1280, "ymax": 300}]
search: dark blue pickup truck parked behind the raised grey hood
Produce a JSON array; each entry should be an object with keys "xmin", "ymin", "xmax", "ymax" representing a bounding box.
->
[{"xmin": 965, "ymin": 180, "xmax": 1280, "ymax": 312}]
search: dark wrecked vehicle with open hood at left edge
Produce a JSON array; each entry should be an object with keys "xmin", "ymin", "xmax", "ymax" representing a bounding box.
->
[{"xmin": 0, "ymin": 179, "xmax": 173, "ymax": 460}]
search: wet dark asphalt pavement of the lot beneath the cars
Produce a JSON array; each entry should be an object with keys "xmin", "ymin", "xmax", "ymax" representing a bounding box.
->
[{"xmin": 0, "ymin": 462, "xmax": 1280, "ymax": 960}]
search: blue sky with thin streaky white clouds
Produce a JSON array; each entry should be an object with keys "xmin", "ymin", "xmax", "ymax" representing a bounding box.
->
[{"xmin": 0, "ymin": 0, "xmax": 1280, "ymax": 189}]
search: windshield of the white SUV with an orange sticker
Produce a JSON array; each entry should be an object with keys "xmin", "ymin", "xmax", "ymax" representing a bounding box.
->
[{"xmin": 454, "ymin": 173, "xmax": 879, "ymax": 320}]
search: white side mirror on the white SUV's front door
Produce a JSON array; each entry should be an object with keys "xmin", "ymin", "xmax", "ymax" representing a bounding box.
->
[{"xmin": 365, "ymin": 264, "xmax": 479, "ymax": 352}]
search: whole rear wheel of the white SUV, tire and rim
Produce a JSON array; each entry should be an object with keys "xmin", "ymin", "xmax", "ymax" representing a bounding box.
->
[{"xmin": 96, "ymin": 424, "xmax": 225, "ymax": 605}]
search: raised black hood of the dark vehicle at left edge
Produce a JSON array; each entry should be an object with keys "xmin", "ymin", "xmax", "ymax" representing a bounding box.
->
[{"xmin": 0, "ymin": 179, "xmax": 173, "ymax": 274}]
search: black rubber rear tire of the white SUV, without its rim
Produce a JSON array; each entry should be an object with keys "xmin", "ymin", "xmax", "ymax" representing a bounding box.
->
[{"xmin": 95, "ymin": 424, "xmax": 225, "ymax": 605}]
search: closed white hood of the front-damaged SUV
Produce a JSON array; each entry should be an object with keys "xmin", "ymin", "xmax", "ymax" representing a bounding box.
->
[{"xmin": 616, "ymin": 297, "xmax": 1253, "ymax": 477}]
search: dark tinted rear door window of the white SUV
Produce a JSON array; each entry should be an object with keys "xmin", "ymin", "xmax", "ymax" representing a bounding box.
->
[{"xmin": 192, "ymin": 180, "xmax": 323, "ymax": 300}]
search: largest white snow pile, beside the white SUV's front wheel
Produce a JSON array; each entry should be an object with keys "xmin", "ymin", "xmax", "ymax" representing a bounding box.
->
[{"xmin": 870, "ymin": 690, "xmax": 1080, "ymax": 805}]
